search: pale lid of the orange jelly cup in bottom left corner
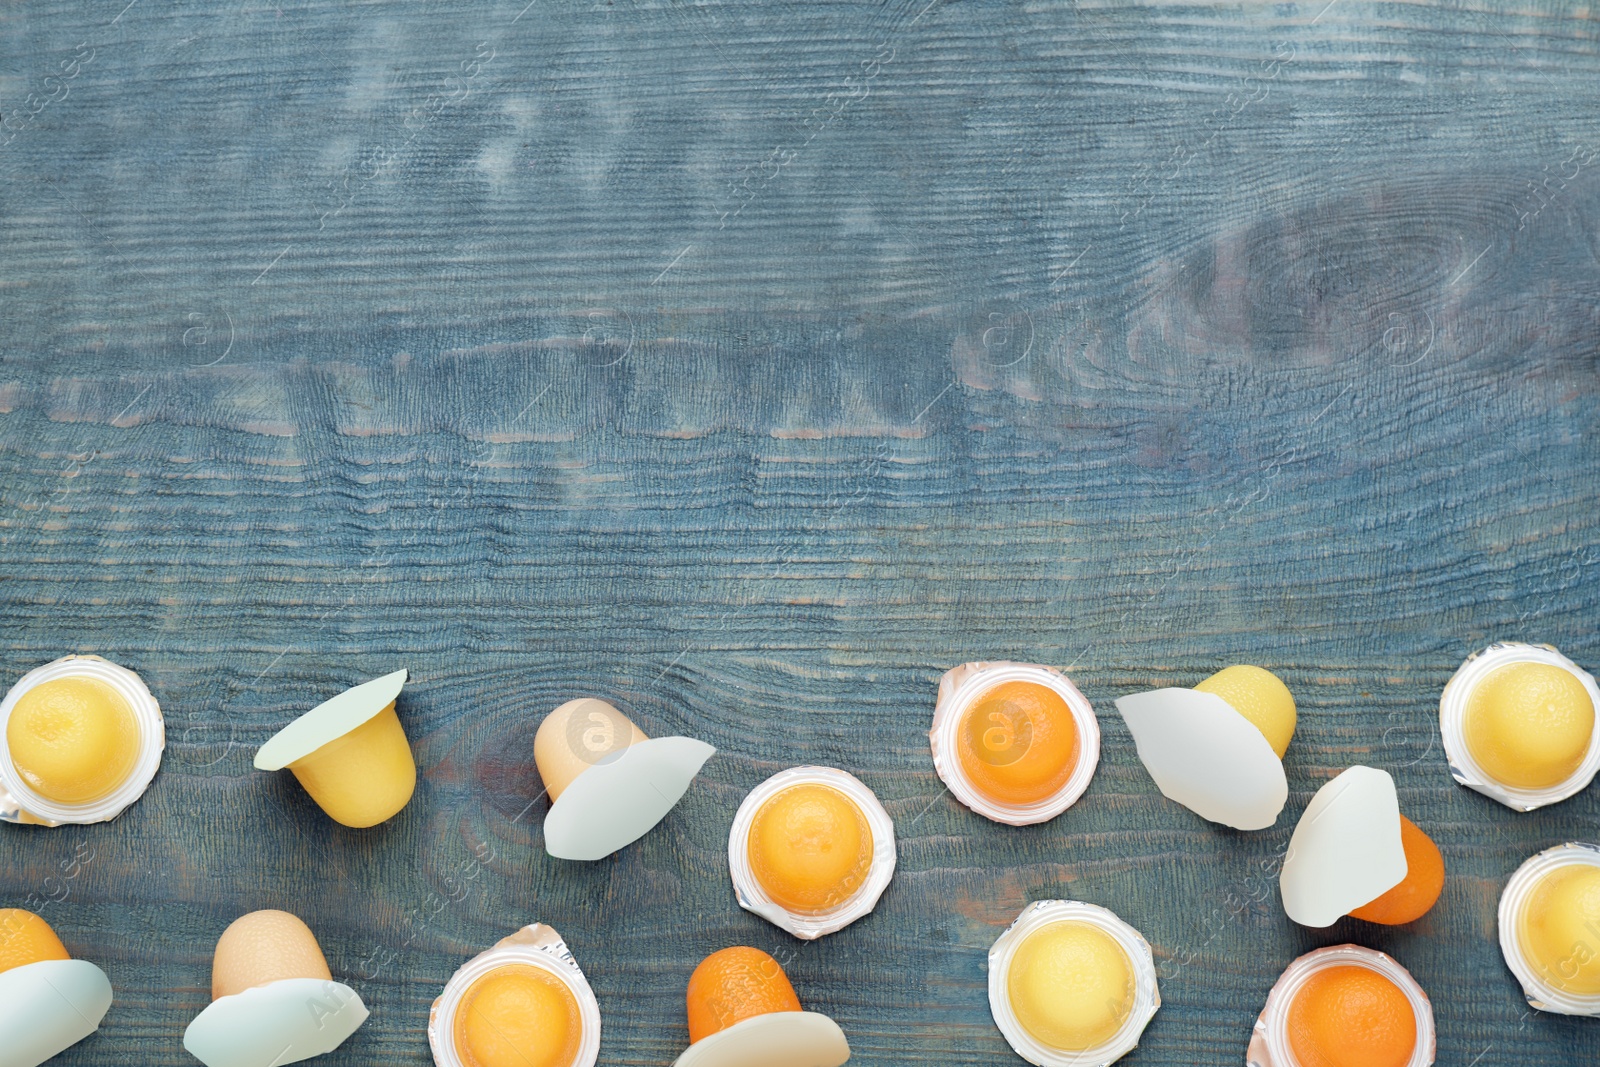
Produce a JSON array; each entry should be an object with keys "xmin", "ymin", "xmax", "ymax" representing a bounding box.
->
[{"xmin": 0, "ymin": 960, "xmax": 110, "ymax": 1067}]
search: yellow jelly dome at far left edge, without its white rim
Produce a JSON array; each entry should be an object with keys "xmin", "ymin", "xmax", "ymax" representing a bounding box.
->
[{"xmin": 5, "ymin": 678, "xmax": 139, "ymax": 805}]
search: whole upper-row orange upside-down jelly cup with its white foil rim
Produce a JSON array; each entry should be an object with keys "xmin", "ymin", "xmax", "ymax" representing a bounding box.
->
[{"xmin": 928, "ymin": 662, "xmax": 1099, "ymax": 825}]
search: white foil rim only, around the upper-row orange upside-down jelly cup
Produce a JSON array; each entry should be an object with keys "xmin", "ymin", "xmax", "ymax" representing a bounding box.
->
[{"xmin": 928, "ymin": 662, "xmax": 1099, "ymax": 825}]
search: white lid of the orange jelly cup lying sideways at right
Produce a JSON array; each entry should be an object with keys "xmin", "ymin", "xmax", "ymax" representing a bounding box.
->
[{"xmin": 1278, "ymin": 766, "xmax": 1408, "ymax": 926}]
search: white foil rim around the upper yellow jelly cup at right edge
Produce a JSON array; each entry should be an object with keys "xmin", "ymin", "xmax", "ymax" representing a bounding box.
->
[{"xmin": 1438, "ymin": 641, "xmax": 1600, "ymax": 811}]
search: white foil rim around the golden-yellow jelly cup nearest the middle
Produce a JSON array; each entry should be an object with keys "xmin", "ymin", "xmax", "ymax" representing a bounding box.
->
[{"xmin": 728, "ymin": 766, "xmax": 894, "ymax": 941}]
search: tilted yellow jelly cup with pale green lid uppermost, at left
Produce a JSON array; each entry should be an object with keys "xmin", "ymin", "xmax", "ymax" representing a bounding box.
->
[{"xmin": 256, "ymin": 670, "xmax": 416, "ymax": 829}]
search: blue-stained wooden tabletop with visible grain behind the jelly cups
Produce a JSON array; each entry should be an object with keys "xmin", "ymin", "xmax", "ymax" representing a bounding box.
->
[{"xmin": 0, "ymin": 0, "xmax": 1600, "ymax": 1067}]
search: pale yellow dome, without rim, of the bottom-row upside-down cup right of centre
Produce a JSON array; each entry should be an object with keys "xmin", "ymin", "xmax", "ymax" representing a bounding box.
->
[{"xmin": 1006, "ymin": 920, "xmax": 1134, "ymax": 1053}]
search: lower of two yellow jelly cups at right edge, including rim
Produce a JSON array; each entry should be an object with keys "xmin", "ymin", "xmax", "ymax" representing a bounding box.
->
[{"xmin": 1498, "ymin": 841, "xmax": 1600, "ymax": 1016}]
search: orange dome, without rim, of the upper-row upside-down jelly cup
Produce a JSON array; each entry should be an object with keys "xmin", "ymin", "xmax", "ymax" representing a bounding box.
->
[{"xmin": 955, "ymin": 681, "xmax": 1078, "ymax": 805}]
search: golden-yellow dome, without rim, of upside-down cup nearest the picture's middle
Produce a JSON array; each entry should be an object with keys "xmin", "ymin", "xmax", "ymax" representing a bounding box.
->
[{"xmin": 749, "ymin": 782, "xmax": 872, "ymax": 913}]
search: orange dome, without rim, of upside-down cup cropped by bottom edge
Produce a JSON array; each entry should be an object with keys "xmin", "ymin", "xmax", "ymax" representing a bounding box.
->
[{"xmin": 1288, "ymin": 965, "xmax": 1416, "ymax": 1067}]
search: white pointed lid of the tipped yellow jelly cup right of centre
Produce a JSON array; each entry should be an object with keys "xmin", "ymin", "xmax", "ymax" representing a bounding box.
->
[{"xmin": 1117, "ymin": 689, "xmax": 1290, "ymax": 830}]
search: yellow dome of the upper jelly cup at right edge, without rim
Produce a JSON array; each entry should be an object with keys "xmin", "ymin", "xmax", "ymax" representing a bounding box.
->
[{"xmin": 1466, "ymin": 664, "xmax": 1595, "ymax": 789}]
